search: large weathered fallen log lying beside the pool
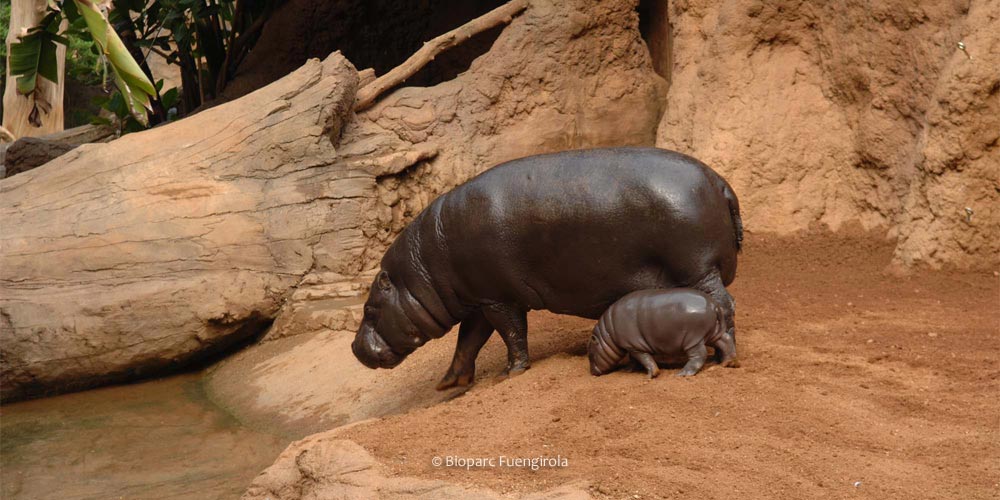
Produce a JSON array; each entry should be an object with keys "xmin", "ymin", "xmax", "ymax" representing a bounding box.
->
[{"xmin": 0, "ymin": 53, "xmax": 360, "ymax": 401}]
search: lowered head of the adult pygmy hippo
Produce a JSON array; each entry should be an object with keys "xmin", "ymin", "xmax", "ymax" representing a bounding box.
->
[{"xmin": 351, "ymin": 271, "xmax": 431, "ymax": 368}]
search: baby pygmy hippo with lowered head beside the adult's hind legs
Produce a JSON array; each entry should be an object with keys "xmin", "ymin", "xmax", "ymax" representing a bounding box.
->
[{"xmin": 587, "ymin": 288, "xmax": 739, "ymax": 378}]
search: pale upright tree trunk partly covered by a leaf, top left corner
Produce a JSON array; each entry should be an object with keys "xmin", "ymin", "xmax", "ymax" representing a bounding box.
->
[{"xmin": 3, "ymin": 0, "xmax": 66, "ymax": 138}]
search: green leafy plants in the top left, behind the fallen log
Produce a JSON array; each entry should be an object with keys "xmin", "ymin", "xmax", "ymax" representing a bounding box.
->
[{"xmin": 3, "ymin": 0, "xmax": 282, "ymax": 135}]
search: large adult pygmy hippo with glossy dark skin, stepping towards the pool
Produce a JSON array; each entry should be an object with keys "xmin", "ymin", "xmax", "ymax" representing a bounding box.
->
[{"xmin": 351, "ymin": 147, "xmax": 743, "ymax": 389}]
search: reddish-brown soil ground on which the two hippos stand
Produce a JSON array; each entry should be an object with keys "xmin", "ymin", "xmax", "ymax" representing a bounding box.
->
[{"xmin": 340, "ymin": 234, "xmax": 1000, "ymax": 499}]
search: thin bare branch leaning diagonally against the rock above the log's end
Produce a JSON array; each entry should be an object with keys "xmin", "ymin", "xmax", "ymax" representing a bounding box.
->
[{"xmin": 354, "ymin": 0, "xmax": 528, "ymax": 111}]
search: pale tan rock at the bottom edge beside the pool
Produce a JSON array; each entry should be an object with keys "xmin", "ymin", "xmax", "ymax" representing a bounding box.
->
[{"xmin": 243, "ymin": 438, "xmax": 591, "ymax": 500}]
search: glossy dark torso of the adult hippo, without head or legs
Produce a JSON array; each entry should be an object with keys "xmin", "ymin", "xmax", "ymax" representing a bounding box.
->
[{"xmin": 402, "ymin": 148, "xmax": 737, "ymax": 318}]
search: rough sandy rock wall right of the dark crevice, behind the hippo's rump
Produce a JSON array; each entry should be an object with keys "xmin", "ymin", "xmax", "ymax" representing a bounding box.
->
[{"xmin": 657, "ymin": 0, "xmax": 1000, "ymax": 267}]
